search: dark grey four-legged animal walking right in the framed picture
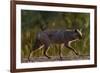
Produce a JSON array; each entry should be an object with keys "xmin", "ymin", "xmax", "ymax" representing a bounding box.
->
[{"xmin": 27, "ymin": 29, "xmax": 82, "ymax": 58}]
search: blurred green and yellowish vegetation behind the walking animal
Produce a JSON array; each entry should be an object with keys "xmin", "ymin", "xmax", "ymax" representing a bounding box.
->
[{"xmin": 21, "ymin": 10, "xmax": 90, "ymax": 58}]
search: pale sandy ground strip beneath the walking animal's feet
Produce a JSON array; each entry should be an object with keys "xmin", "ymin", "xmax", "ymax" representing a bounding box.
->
[{"xmin": 21, "ymin": 55, "xmax": 90, "ymax": 63}]
